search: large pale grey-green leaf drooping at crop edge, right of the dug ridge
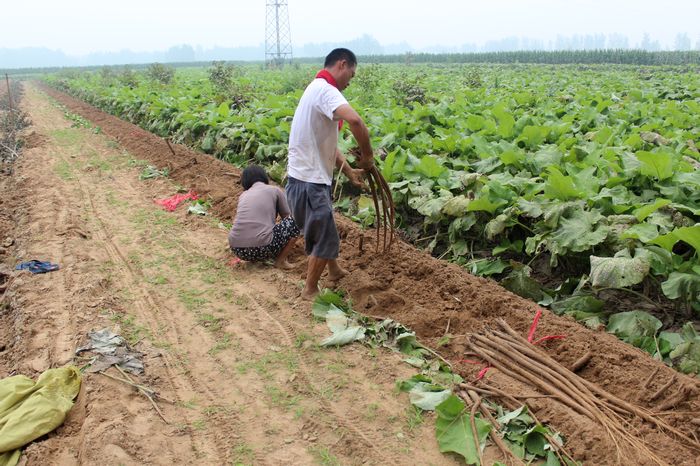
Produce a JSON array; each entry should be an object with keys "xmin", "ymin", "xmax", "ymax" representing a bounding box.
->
[{"xmin": 590, "ymin": 249, "xmax": 650, "ymax": 288}]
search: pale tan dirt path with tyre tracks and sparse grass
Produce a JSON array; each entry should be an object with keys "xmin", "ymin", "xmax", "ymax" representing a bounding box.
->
[{"xmin": 0, "ymin": 86, "xmax": 457, "ymax": 465}]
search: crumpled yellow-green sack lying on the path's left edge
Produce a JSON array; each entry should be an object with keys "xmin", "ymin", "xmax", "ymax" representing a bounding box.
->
[{"xmin": 0, "ymin": 366, "xmax": 81, "ymax": 466}]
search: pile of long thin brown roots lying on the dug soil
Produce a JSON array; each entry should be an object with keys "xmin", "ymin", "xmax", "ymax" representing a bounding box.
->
[{"xmin": 459, "ymin": 319, "xmax": 700, "ymax": 465}]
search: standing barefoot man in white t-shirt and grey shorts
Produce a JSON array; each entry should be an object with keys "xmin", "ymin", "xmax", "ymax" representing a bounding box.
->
[{"xmin": 286, "ymin": 48, "xmax": 374, "ymax": 300}]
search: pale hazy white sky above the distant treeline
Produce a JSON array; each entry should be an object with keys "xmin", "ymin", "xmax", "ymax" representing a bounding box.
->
[{"xmin": 6, "ymin": 0, "xmax": 700, "ymax": 54}]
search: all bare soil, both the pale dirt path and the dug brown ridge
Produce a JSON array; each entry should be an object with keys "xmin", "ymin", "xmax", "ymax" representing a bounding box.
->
[{"xmin": 0, "ymin": 83, "xmax": 700, "ymax": 465}]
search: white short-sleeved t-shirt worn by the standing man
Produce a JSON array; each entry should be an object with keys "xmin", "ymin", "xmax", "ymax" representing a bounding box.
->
[{"xmin": 287, "ymin": 78, "xmax": 348, "ymax": 186}]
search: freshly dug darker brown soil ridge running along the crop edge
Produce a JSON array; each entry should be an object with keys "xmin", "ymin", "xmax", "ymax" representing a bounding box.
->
[{"xmin": 45, "ymin": 84, "xmax": 700, "ymax": 464}]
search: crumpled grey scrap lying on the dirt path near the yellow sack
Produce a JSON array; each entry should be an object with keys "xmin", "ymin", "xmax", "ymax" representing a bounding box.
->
[{"xmin": 75, "ymin": 328, "xmax": 143, "ymax": 375}]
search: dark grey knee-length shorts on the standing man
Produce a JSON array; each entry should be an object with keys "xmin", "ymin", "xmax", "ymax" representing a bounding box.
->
[{"xmin": 285, "ymin": 177, "xmax": 340, "ymax": 259}]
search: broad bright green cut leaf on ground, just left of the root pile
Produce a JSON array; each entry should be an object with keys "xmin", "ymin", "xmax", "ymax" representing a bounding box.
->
[{"xmin": 435, "ymin": 395, "xmax": 491, "ymax": 464}]
